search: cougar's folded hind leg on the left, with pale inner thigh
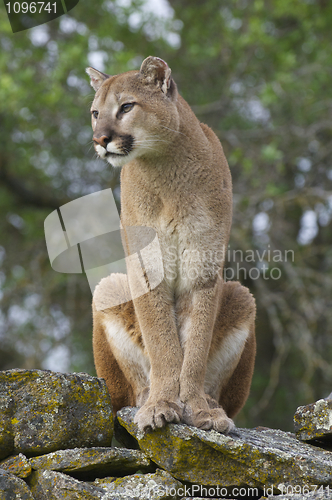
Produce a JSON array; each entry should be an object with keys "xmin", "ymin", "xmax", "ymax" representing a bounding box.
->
[{"xmin": 93, "ymin": 274, "xmax": 150, "ymax": 413}]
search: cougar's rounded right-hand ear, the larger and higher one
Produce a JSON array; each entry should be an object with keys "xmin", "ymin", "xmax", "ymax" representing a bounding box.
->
[{"xmin": 140, "ymin": 56, "xmax": 176, "ymax": 96}]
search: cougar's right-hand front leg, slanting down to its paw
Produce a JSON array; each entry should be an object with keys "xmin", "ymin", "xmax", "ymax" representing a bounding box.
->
[{"xmin": 180, "ymin": 280, "xmax": 234, "ymax": 432}]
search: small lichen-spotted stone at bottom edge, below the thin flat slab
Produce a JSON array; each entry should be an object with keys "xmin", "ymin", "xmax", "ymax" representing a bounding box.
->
[{"xmin": 97, "ymin": 470, "xmax": 183, "ymax": 500}]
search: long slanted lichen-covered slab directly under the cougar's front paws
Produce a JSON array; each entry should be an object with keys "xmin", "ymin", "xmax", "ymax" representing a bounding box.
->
[{"xmin": 117, "ymin": 408, "xmax": 332, "ymax": 493}]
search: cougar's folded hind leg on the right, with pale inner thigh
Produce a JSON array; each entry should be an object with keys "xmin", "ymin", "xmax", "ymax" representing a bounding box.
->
[{"xmin": 205, "ymin": 281, "xmax": 256, "ymax": 418}]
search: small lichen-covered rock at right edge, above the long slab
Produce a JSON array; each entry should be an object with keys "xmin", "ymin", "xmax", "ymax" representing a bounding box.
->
[{"xmin": 294, "ymin": 399, "xmax": 332, "ymax": 443}]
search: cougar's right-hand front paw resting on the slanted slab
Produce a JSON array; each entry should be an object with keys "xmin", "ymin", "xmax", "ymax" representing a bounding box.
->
[{"xmin": 182, "ymin": 405, "xmax": 235, "ymax": 434}]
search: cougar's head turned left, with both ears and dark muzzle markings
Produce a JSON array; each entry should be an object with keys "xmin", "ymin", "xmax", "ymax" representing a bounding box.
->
[{"xmin": 86, "ymin": 56, "xmax": 179, "ymax": 167}]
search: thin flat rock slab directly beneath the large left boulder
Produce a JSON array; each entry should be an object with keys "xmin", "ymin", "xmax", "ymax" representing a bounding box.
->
[{"xmin": 30, "ymin": 448, "xmax": 155, "ymax": 481}]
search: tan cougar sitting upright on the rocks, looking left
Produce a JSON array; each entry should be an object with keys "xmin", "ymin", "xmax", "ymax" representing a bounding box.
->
[{"xmin": 87, "ymin": 57, "xmax": 255, "ymax": 432}]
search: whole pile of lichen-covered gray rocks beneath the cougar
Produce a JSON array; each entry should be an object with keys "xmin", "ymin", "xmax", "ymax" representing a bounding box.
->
[{"xmin": 0, "ymin": 370, "xmax": 332, "ymax": 500}]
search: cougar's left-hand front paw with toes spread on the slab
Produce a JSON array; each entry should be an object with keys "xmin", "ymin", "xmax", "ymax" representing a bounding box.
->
[{"xmin": 134, "ymin": 401, "xmax": 182, "ymax": 432}]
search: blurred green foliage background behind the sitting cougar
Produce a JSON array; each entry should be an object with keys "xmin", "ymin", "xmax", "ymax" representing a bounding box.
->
[{"xmin": 0, "ymin": 0, "xmax": 332, "ymax": 429}]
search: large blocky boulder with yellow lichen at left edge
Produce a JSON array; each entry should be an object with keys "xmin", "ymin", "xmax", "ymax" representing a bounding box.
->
[{"xmin": 0, "ymin": 370, "xmax": 113, "ymax": 459}]
